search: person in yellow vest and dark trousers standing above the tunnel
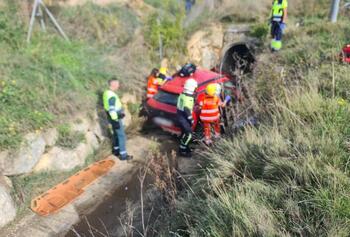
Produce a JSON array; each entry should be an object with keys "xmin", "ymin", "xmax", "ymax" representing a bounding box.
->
[{"xmin": 271, "ymin": 0, "xmax": 288, "ymax": 52}]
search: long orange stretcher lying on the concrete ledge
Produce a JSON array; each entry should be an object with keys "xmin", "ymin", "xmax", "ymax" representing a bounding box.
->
[{"xmin": 31, "ymin": 159, "xmax": 115, "ymax": 216}]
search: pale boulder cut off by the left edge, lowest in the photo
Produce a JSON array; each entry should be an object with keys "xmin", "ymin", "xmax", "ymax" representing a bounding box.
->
[{"xmin": 0, "ymin": 183, "xmax": 16, "ymax": 228}]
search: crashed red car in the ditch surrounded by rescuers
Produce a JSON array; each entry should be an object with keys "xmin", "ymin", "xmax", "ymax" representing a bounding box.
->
[{"xmin": 144, "ymin": 69, "xmax": 234, "ymax": 135}]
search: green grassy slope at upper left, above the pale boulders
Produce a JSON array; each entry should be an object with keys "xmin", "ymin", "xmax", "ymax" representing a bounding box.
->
[{"xmin": 0, "ymin": 3, "xmax": 138, "ymax": 149}]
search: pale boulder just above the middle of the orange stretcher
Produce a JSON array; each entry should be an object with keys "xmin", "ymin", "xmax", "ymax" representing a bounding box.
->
[{"xmin": 34, "ymin": 147, "xmax": 85, "ymax": 172}]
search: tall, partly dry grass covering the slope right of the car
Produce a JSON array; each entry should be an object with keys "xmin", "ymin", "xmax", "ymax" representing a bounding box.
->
[{"xmin": 157, "ymin": 1, "xmax": 350, "ymax": 237}]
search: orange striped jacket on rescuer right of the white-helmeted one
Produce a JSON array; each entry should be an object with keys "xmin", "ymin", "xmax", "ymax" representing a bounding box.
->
[{"xmin": 199, "ymin": 96, "xmax": 220, "ymax": 122}]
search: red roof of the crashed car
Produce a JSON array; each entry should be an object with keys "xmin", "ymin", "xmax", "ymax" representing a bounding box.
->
[{"xmin": 161, "ymin": 69, "xmax": 224, "ymax": 94}]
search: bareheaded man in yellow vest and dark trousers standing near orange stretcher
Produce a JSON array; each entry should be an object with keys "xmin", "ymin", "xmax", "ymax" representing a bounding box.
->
[{"xmin": 103, "ymin": 77, "xmax": 132, "ymax": 160}]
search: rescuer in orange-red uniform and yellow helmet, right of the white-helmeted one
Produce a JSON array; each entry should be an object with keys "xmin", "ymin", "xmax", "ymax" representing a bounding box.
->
[{"xmin": 199, "ymin": 84, "xmax": 231, "ymax": 145}]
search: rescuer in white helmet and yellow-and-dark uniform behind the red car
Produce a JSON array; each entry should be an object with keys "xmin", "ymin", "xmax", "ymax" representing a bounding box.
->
[{"xmin": 177, "ymin": 78, "xmax": 198, "ymax": 157}]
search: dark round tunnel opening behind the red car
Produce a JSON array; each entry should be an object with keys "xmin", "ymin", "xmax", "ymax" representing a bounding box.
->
[{"xmin": 221, "ymin": 43, "xmax": 256, "ymax": 75}]
